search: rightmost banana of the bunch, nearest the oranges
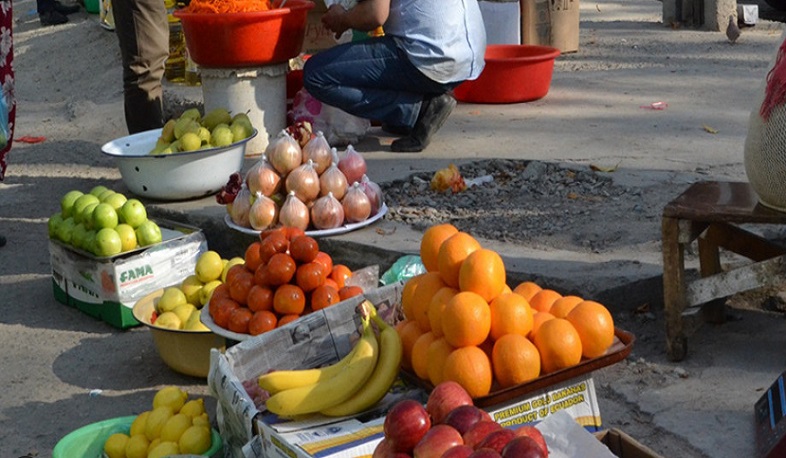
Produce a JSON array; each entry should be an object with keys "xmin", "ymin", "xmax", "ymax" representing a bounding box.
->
[{"xmin": 320, "ymin": 314, "xmax": 402, "ymax": 417}]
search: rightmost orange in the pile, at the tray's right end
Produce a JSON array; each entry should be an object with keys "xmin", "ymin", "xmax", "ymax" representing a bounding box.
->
[{"xmin": 567, "ymin": 301, "xmax": 614, "ymax": 358}]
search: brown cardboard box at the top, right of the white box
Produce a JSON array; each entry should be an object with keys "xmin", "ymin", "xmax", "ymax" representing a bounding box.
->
[{"xmin": 521, "ymin": 0, "xmax": 579, "ymax": 53}]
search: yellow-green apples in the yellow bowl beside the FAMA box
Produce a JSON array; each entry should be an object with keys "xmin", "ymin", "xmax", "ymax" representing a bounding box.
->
[{"xmin": 144, "ymin": 250, "xmax": 236, "ymax": 331}]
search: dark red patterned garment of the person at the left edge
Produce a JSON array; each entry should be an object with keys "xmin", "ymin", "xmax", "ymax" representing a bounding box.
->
[{"xmin": 0, "ymin": 0, "xmax": 16, "ymax": 181}]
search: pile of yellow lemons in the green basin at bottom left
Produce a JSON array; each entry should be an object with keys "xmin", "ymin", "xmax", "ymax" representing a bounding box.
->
[{"xmin": 104, "ymin": 386, "xmax": 217, "ymax": 458}]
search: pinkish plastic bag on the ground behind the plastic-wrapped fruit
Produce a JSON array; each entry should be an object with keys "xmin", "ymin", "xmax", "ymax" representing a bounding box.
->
[{"xmin": 289, "ymin": 89, "xmax": 371, "ymax": 146}]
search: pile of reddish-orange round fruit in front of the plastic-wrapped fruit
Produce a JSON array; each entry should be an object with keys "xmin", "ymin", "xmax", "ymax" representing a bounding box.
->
[{"xmin": 208, "ymin": 227, "xmax": 363, "ymax": 335}]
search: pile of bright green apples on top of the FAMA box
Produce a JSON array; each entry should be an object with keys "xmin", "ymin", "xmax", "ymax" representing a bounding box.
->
[{"xmin": 48, "ymin": 185, "xmax": 162, "ymax": 257}]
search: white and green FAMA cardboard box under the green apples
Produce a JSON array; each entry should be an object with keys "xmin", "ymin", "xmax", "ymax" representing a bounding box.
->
[{"xmin": 49, "ymin": 220, "xmax": 207, "ymax": 329}]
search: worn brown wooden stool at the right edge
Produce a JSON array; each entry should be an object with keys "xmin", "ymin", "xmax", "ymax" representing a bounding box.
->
[{"xmin": 662, "ymin": 181, "xmax": 786, "ymax": 361}]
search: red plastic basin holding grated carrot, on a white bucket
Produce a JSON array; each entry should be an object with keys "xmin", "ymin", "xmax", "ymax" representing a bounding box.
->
[{"xmin": 174, "ymin": 0, "xmax": 314, "ymax": 68}]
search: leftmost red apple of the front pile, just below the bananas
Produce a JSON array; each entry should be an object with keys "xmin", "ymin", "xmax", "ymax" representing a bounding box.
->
[{"xmin": 382, "ymin": 399, "xmax": 431, "ymax": 453}]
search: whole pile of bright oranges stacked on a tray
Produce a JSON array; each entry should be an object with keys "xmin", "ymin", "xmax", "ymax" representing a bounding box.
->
[{"xmin": 397, "ymin": 224, "xmax": 614, "ymax": 397}]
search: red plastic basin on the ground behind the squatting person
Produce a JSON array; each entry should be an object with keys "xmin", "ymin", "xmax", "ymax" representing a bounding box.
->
[{"xmin": 453, "ymin": 45, "xmax": 560, "ymax": 103}]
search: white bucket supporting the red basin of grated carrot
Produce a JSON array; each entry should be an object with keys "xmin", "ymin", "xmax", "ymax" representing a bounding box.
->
[{"xmin": 200, "ymin": 63, "xmax": 287, "ymax": 156}]
